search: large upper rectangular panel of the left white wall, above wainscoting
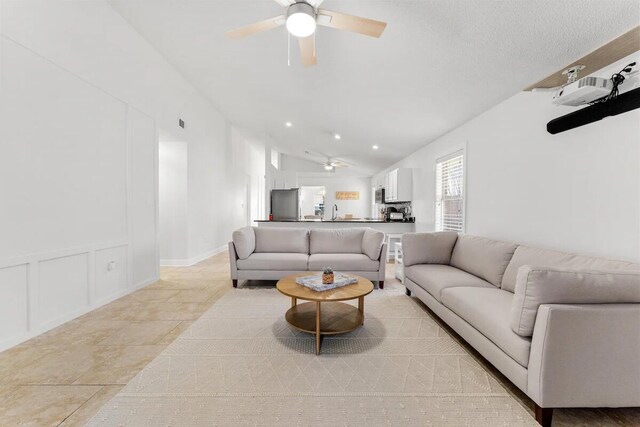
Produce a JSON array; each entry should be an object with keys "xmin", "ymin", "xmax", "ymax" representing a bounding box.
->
[{"xmin": 0, "ymin": 39, "xmax": 127, "ymax": 259}]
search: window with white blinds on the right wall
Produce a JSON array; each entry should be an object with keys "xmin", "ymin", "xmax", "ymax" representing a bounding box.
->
[{"xmin": 436, "ymin": 151, "xmax": 464, "ymax": 231}]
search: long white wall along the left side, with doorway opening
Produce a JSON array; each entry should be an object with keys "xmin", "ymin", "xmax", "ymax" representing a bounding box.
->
[{"xmin": 0, "ymin": 1, "xmax": 264, "ymax": 350}]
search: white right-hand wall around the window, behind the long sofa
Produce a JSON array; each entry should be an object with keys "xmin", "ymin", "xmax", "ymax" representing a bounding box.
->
[{"xmin": 373, "ymin": 81, "xmax": 640, "ymax": 261}]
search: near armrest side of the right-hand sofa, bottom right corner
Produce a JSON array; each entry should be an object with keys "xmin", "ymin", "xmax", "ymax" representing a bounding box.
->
[{"xmin": 527, "ymin": 304, "xmax": 640, "ymax": 408}]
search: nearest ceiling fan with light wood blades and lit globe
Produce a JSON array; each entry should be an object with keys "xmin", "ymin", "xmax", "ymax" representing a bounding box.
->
[{"xmin": 225, "ymin": 0, "xmax": 387, "ymax": 67}]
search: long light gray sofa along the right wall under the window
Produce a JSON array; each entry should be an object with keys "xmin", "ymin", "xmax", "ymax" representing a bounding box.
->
[{"xmin": 402, "ymin": 232, "xmax": 640, "ymax": 425}]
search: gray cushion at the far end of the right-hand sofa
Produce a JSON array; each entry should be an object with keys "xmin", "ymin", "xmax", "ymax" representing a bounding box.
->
[{"xmin": 402, "ymin": 231, "xmax": 458, "ymax": 266}]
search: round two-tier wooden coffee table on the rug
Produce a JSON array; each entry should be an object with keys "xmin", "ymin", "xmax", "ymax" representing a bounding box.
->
[{"xmin": 276, "ymin": 272, "xmax": 373, "ymax": 354}]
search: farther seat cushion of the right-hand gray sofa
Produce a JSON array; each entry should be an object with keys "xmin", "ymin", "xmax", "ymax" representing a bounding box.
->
[{"xmin": 404, "ymin": 264, "xmax": 495, "ymax": 301}]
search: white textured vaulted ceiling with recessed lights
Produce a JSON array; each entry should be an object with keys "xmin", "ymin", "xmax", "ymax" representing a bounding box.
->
[{"xmin": 110, "ymin": 0, "xmax": 640, "ymax": 174}]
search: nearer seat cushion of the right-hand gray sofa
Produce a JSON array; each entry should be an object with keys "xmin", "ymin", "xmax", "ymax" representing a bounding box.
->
[{"xmin": 442, "ymin": 287, "xmax": 531, "ymax": 368}]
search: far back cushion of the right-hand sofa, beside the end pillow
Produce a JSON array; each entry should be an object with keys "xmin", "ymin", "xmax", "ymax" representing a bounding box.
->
[{"xmin": 451, "ymin": 235, "xmax": 516, "ymax": 287}]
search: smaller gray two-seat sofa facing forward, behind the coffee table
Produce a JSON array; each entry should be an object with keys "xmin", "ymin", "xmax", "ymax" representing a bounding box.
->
[{"xmin": 229, "ymin": 227, "xmax": 387, "ymax": 289}]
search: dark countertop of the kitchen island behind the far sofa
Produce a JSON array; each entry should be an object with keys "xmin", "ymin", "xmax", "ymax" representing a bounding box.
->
[{"xmin": 255, "ymin": 219, "xmax": 416, "ymax": 234}]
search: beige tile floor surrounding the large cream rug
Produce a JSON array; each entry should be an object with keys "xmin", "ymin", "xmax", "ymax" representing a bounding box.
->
[{"xmin": 0, "ymin": 253, "xmax": 640, "ymax": 427}]
